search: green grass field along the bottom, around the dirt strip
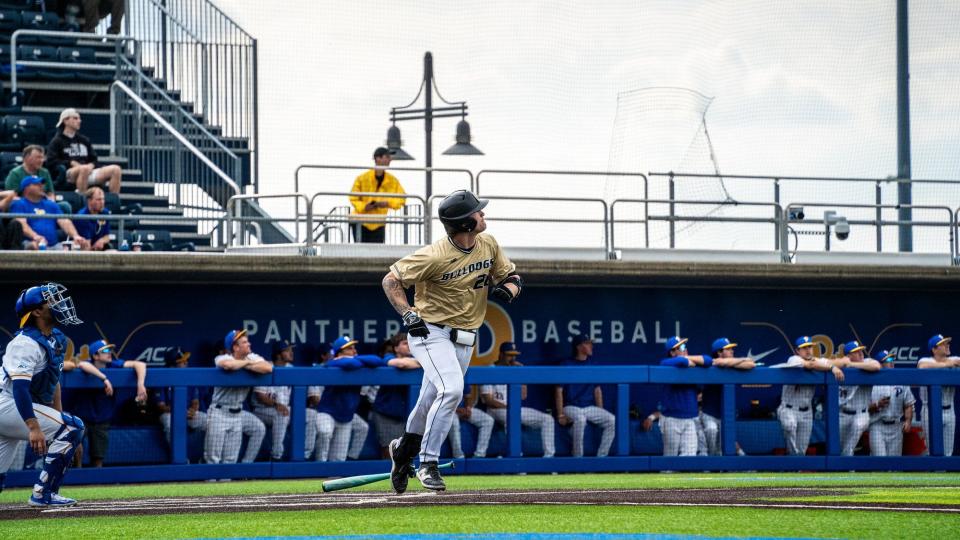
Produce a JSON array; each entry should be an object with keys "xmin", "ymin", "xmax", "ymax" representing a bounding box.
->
[{"xmin": 0, "ymin": 473, "xmax": 960, "ymax": 539}]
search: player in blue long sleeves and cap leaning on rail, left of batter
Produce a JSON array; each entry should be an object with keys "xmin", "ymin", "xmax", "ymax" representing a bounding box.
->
[{"xmin": 317, "ymin": 336, "xmax": 387, "ymax": 461}]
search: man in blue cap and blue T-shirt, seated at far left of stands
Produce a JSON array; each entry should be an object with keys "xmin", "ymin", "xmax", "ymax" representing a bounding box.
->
[{"xmin": 10, "ymin": 176, "xmax": 90, "ymax": 250}]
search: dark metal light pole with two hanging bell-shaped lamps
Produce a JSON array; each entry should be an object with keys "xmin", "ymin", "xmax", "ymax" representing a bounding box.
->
[{"xmin": 387, "ymin": 51, "xmax": 483, "ymax": 200}]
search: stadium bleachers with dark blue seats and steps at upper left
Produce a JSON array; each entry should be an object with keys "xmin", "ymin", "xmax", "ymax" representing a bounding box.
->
[{"xmin": 0, "ymin": 1, "xmax": 249, "ymax": 250}]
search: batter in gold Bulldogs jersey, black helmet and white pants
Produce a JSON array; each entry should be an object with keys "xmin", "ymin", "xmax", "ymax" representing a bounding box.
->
[{"xmin": 383, "ymin": 190, "xmax": 523, "ymax": 493}]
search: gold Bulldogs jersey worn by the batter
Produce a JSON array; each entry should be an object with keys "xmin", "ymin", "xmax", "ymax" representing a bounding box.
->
[{"xmin": 390, "ymin": 233, "xmax": 516, "ymax": 330}]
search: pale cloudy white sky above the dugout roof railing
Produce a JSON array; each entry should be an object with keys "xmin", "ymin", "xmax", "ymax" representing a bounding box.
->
[{"xmin": 218, "ymin": 0, "xmax": 960, "ymax": 251}]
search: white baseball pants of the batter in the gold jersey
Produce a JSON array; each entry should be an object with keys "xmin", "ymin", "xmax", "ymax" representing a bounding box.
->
[{"xmin": 407, "ymin": 323, "xmax": 473, "ymax": 463}]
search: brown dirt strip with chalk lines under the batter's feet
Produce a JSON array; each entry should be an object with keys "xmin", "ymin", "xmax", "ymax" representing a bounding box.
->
[{"xmin": 0, "ymin": 486, "xmax": 960, "ymax": 520}]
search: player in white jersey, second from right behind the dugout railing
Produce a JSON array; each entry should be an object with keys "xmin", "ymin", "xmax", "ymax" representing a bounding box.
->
[{"xmin": 869, "ymin": 351, "xmax": 916, "ymax": 456}]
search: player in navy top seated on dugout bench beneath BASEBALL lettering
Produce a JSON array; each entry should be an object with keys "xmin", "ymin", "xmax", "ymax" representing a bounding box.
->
[{"xmin": 554, "ymin": 334, "xmax": 616, "ymax": 457}]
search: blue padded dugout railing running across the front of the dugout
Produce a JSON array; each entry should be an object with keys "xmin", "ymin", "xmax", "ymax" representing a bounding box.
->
[{"xmin": 7, "ymin": 366, "xmax": 960, "ymax": 486}]
